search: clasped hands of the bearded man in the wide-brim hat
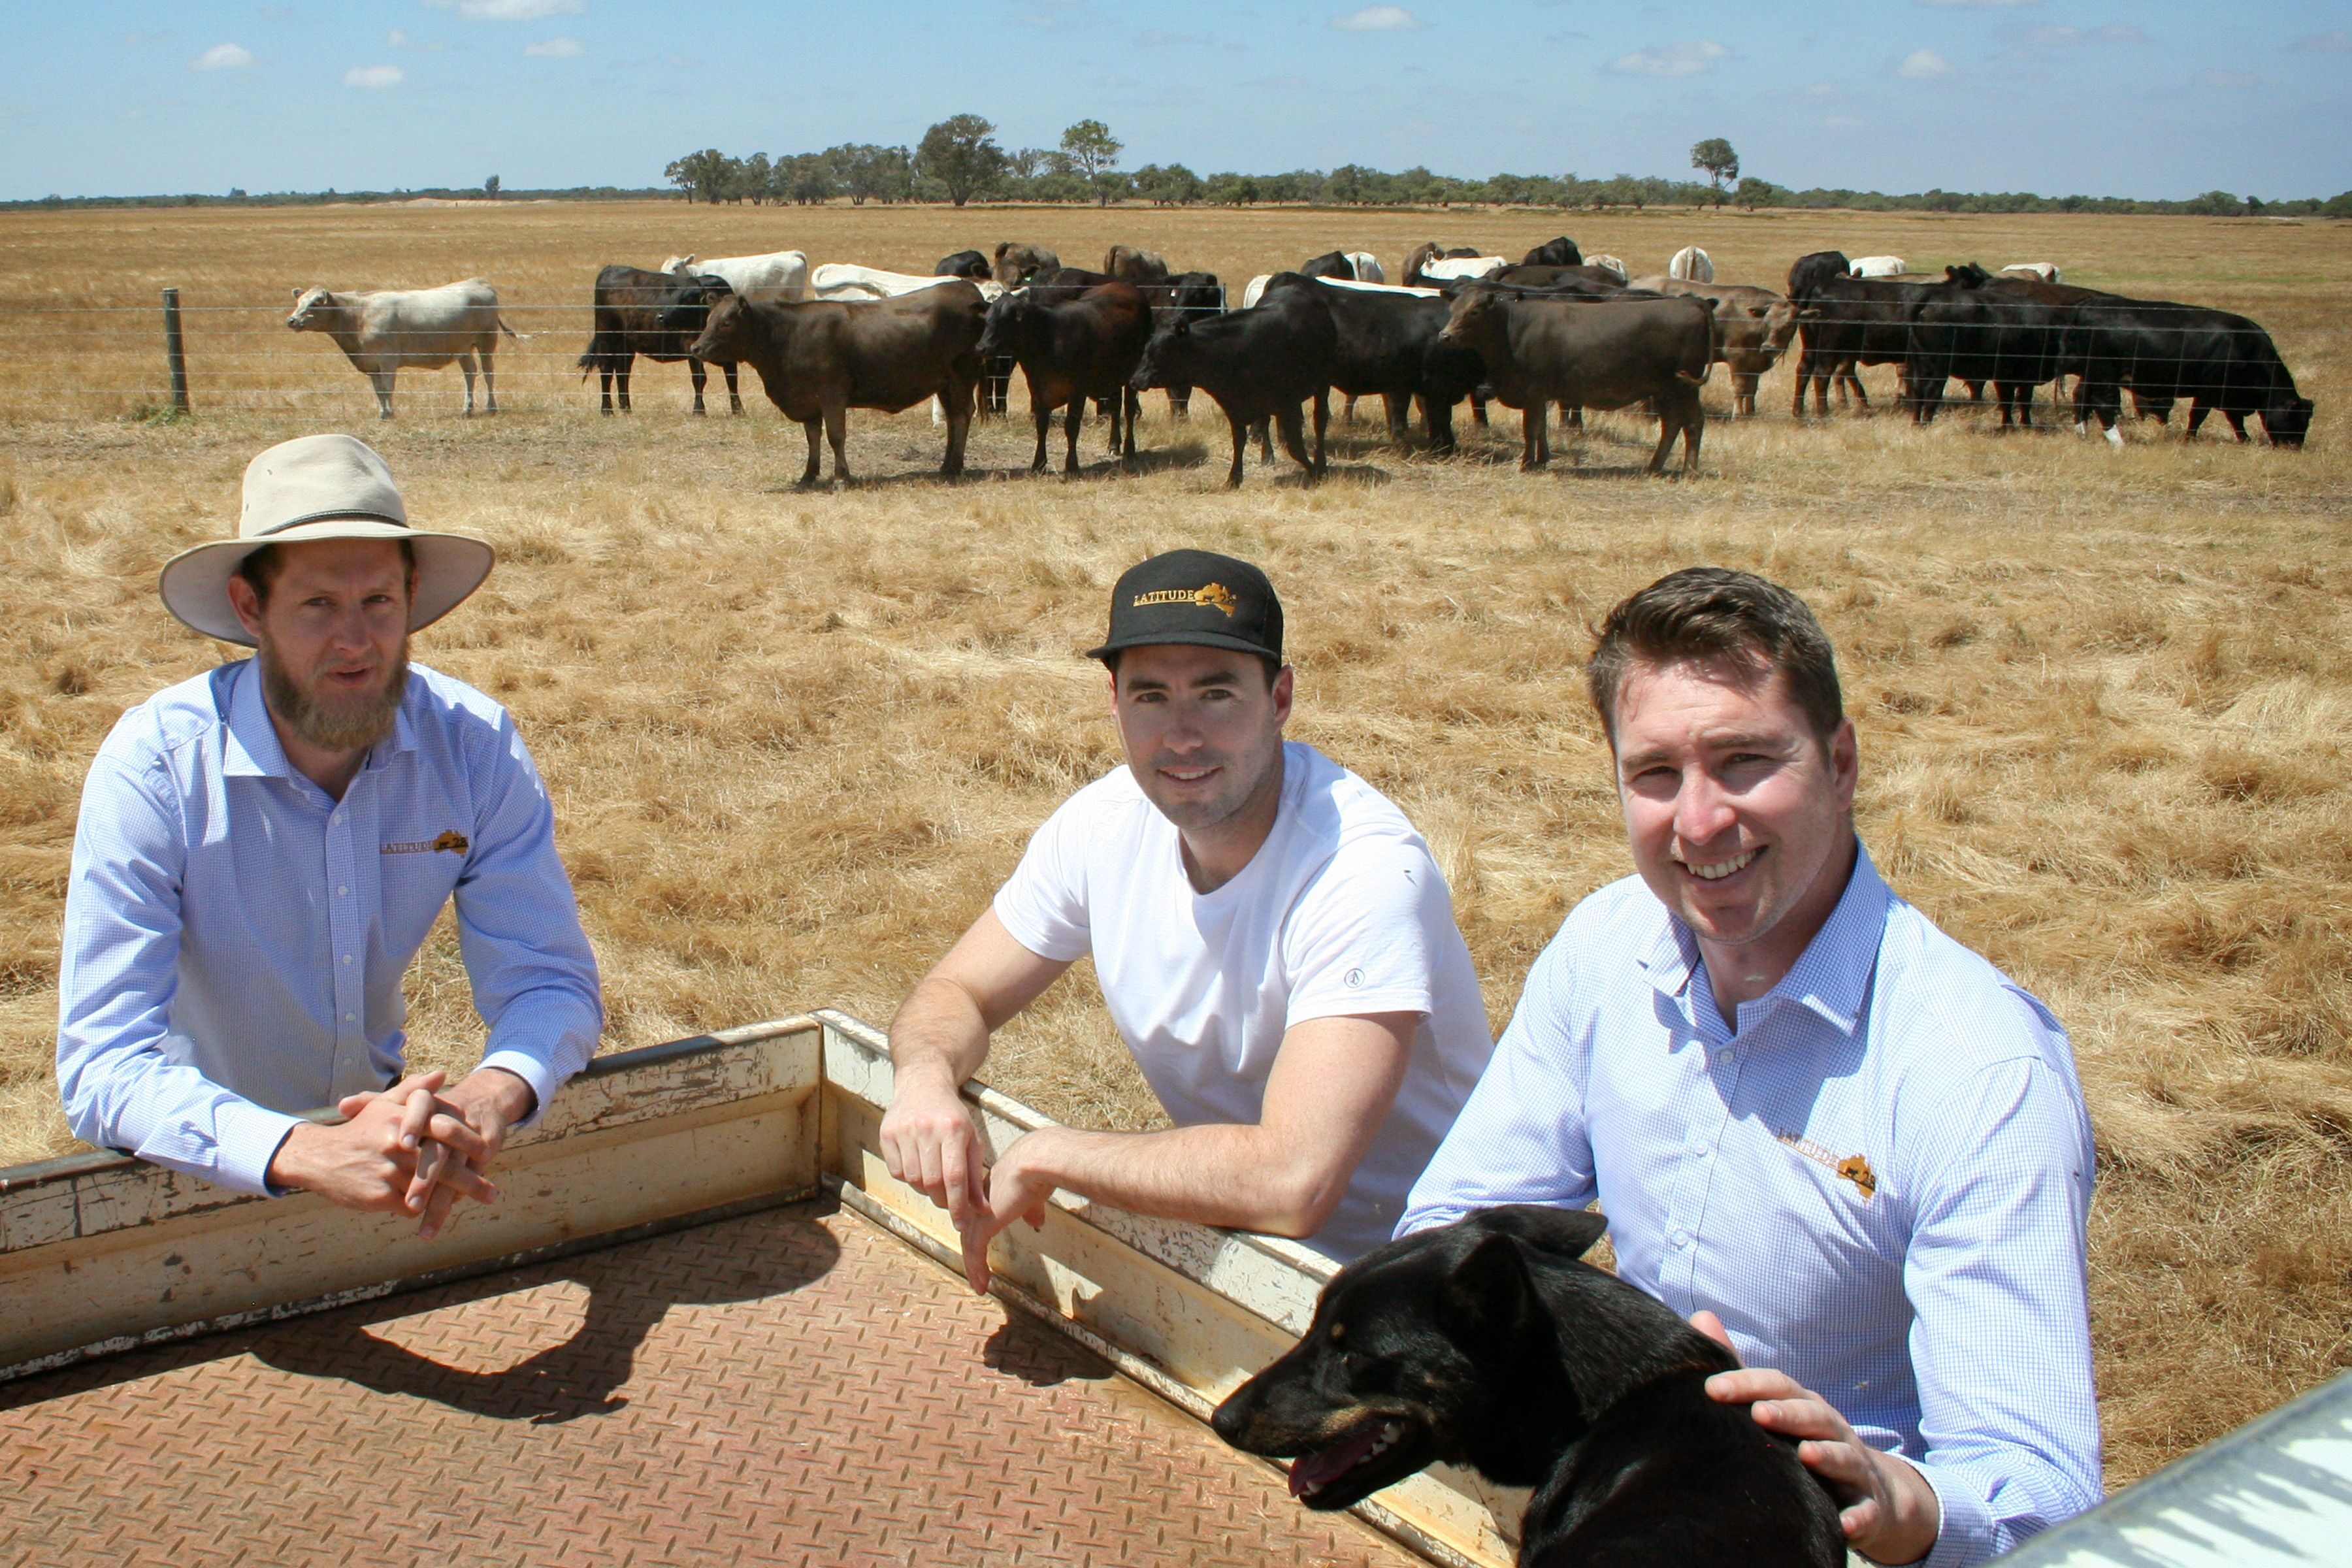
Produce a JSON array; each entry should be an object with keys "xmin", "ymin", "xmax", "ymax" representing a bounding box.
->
[{"xmin": 268, "ymin": 1068, "xmax": 536, "ymax": 1241}]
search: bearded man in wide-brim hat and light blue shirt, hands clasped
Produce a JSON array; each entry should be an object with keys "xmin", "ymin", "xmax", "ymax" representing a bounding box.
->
[{"xmin": 56, "ymin": 435, "xmax": 604, "ymax": 1237}]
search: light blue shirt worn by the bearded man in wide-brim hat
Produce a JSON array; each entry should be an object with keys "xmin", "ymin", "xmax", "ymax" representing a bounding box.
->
[{"xmin": 56, "ymin": 658, "xmax": 604, "ymax": 1192}]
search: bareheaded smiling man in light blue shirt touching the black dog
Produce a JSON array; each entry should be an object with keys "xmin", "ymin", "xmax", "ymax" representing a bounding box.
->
[{"xmin": 1399, "ymin": 569, "xmax": 2100, "ymax": 1568}]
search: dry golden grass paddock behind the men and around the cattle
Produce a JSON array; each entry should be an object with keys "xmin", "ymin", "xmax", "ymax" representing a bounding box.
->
[{"xmin": 0, "ymin": 204, "xmax": 2352, "ymax": 1483}]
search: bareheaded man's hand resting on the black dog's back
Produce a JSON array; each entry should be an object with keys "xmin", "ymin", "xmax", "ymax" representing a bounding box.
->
[{"xmin": 1691, "ymin": 1312, "xmax": 1943, "ymax": 1563}]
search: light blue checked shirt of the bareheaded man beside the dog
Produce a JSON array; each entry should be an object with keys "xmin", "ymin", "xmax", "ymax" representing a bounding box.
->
[{"xmin": 1397, "ymin": 853, "xmax": 2100, "ymax": 1568}]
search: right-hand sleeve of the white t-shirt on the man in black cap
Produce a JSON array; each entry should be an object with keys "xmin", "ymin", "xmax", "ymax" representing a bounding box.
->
[{"xmin": 1282, "ymin": 841, "xmax": 1461, "ymax": 1030}]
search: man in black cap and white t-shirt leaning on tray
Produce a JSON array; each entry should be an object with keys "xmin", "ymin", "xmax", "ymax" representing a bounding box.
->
[{"xmin": 882, "ymin": 550, "xmax": 1494, "ymax": 1290}]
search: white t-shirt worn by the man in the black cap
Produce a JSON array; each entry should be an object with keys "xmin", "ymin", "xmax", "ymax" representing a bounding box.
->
[{"xmin": 995, "ymin": 740, "xmax": 1494, "ymax": 1260}]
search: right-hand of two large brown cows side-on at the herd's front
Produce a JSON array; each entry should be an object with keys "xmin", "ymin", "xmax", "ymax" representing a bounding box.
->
[{"xmin": 1444, "ymin": 287, "xmax": 1714, "ymax": 472}]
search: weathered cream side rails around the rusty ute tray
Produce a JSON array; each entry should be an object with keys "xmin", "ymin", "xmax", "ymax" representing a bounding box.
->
[{"xmin": 0, "ymin": 1009, "xmax": 1524, "ymax": 1568}]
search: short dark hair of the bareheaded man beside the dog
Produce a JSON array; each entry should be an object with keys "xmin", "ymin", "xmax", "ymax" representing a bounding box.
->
[{"xmin": 1585, "ymin": 566, "xmax": 1846, "ymax": 750}]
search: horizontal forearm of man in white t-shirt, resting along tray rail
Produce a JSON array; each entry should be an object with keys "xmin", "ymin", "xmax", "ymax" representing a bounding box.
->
[{"xmin": 1004, "ymin": 1124, "xmax": 1350, "ymax": 1237}]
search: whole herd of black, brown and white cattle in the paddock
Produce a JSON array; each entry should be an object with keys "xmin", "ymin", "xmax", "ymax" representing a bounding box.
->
[{"xmin": 287, "ymin": 235, "xmax": 2312, "ymax": 484}]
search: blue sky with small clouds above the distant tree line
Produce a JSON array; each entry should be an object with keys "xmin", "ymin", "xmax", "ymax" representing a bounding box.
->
[{"xmin": 0, "ymin": 0, "xmax": 2352, "ymax": 197}]
